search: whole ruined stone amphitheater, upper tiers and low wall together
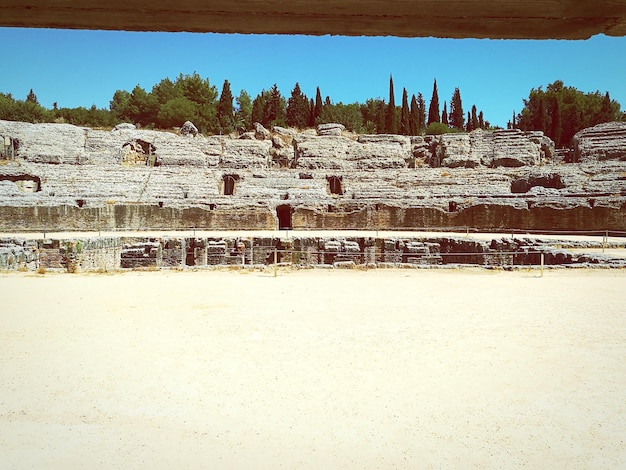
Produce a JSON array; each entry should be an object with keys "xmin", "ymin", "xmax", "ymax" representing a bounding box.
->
[{"xmin": 0, "ymin": 121, "xmax": 626, "ymax": 269}]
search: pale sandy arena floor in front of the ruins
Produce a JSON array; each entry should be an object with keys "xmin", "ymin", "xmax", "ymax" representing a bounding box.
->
[{"xmin": 0, "ymin": 269, "xmax": 626, "ymax": 469}]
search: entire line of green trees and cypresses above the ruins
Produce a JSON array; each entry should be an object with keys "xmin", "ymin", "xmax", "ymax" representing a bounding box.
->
[{"xmin": 0, "ymin": 72, "xmax": 626, "ymax": 146}]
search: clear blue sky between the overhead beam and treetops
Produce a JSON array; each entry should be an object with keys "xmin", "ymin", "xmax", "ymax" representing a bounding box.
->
[{"xmin": 0, "ymin": 28, "xmax": 626, "ymax": 126}]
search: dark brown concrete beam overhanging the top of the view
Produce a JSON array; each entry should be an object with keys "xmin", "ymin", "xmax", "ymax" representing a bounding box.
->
[{"xmin": 0, "ymin": 0, "xmax": 626, "ymax": 39}]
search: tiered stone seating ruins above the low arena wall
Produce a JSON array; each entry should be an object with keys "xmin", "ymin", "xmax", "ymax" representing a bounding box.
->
[{"xmin": 0, "ymin": 121, "xmax": 626, "ymax": 232}]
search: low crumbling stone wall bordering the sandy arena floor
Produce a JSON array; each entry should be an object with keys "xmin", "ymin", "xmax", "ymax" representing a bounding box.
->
[{"xmin": 0, "ymin": 235, "xmax": 626, "ymax": 272}]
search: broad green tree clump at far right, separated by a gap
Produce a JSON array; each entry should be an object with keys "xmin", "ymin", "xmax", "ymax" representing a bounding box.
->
[{"xmin": 517, "ymin": 80, "xmax": 622, "ymax": 147}]
